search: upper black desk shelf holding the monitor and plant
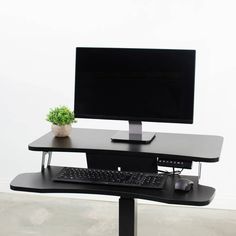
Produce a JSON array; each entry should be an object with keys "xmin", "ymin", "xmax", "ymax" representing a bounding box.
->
[{"xmin": 29, "ymin": 128, "xmax": 223, "ymax": 162}]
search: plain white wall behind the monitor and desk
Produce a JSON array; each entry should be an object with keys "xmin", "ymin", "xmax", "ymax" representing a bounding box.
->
[{"xmin": 0, "ymin": 0, "xmax": 236, "ymax": 207}]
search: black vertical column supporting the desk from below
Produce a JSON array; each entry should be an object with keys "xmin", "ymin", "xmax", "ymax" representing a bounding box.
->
[{"xmin": 119, "ymin": 197, "xmax": 137, "ymax": 236}]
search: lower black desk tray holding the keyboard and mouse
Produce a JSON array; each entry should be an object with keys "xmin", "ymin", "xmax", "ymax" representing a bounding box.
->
[{"xmin": 10, "ymin": 166, "xmax": 215, "ymax": 206}]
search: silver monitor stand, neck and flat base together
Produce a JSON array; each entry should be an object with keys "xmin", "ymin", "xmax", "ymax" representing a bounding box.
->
[{"xmin": 111, "ymin": 121, "xmax": 156, "ymax": 143}]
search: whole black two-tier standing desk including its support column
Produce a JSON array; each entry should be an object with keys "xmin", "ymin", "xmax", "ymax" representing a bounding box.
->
[{"xmin": 10, "ymin": 128, "xmax": 223, "ymax": 236}]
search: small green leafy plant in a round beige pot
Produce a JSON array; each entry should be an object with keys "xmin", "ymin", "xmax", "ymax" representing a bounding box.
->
[{"xmin": 47, "ymin": 106, "xmax": 76, "ymax": 137}]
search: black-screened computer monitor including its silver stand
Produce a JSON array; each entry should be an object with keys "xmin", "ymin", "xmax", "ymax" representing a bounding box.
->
[{"xmin": 74, "ymin": 47, "xmax": 195, "ymax": 143}]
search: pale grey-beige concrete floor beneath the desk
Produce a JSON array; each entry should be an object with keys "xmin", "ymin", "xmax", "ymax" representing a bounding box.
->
[{"xmin": 0, "ymin": 193, "xmax": 236, "ymax": 236}]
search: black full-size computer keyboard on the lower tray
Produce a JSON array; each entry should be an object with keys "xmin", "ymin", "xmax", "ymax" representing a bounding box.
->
[{"xmin": 53, "ymin": 167, "xmax": 167, "ymax": 189}]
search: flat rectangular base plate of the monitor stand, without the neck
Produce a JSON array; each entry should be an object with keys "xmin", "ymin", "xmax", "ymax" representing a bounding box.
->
[{"xmin": 111, "ymin": 131, "xmax": 156, "ymax": 144}]
